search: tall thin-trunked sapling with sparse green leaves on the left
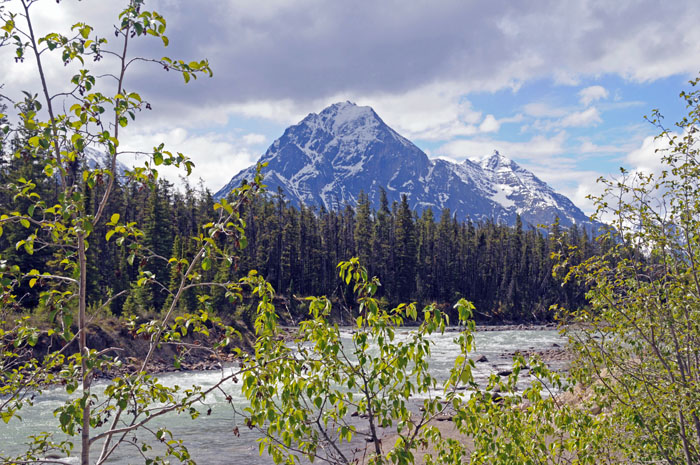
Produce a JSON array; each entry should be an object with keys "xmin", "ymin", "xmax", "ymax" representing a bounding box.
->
[{"xmin": 0, "ymin": 0, "xmax": 254, "ymax": 465}]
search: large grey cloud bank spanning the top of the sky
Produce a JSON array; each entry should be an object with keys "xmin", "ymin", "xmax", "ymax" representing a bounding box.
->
[{"xmin": 3, "ymin": 0, "xmax": 700, "ymax": 121}]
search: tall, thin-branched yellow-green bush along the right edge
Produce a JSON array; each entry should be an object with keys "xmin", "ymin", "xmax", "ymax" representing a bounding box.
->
[{"xmin": 569, "ymin": 79, "xmax": 700, "ymax": 464}]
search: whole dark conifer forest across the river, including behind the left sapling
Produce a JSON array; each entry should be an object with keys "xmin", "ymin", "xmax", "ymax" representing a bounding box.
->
[{"xmin": 0, "ymin": 135, "xmax": 595, "ymax": 321}]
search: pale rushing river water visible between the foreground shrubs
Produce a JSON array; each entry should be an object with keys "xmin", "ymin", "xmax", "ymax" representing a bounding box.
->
[{"xmin": 0, "ymin": 330, "xmax": 563, "ymax": 465}]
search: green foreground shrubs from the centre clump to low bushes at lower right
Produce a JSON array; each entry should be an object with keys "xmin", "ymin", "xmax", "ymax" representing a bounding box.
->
[{"xmin": 242, "ymin": 259, "xmax": 607, "ymax": 464}]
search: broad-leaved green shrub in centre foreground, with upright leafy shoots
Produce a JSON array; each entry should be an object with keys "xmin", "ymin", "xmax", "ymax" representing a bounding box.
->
[{"xmin": 243, "ymin": 259, "xmax": 473, "ymax": 463}]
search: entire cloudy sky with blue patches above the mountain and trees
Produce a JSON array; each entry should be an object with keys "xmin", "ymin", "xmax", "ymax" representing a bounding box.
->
[{"xmin": 0, "ymin": 0, "xmax": 700, "ymax": 212}]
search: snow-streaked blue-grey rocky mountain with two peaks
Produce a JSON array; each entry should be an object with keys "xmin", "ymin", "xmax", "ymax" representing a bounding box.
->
[{"xmin": 215, "ymin": 102, "xmax": 593, "ymax": 229}]
